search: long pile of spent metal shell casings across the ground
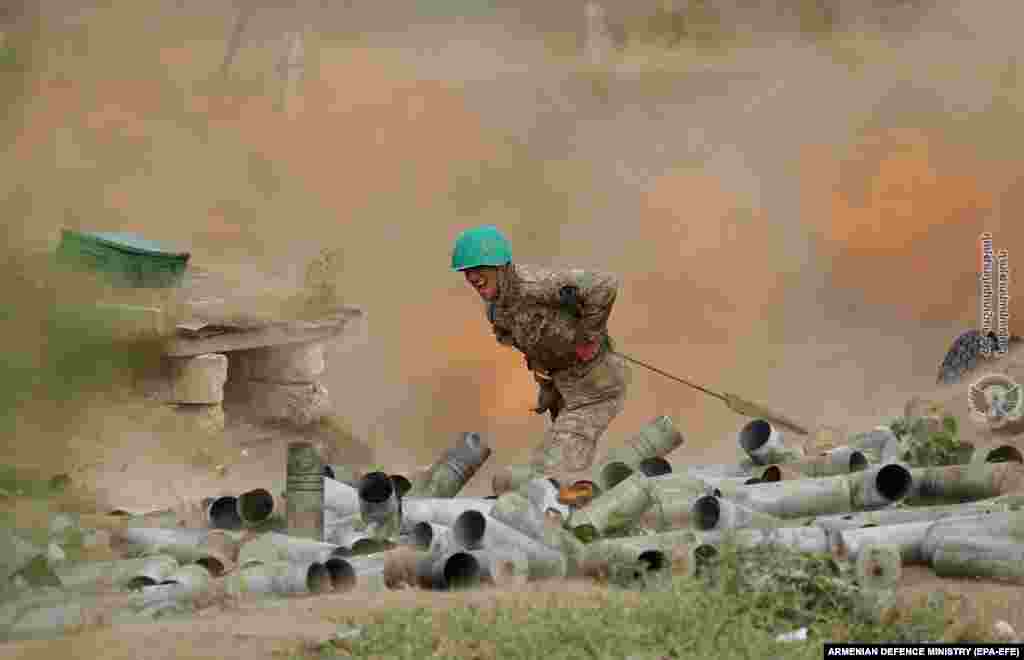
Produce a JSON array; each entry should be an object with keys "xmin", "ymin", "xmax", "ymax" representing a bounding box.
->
[{"xmin": 0, "ymin": 416, "xmax": 1024, "ymax": 639}]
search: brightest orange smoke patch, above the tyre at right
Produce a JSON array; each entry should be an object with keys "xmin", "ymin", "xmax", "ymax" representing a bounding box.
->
[{"xmin": 802, "ymin": 129, "xmax": 997, "ymax": 320}]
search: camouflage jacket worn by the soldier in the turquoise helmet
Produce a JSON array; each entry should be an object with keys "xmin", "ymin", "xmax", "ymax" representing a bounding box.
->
[{"xmin": 487, "ymin": 264, "xmax": 618, "ymax": 373}]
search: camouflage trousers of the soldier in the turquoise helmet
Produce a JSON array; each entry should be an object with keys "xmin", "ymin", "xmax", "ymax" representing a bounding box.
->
[{"xmin": 529, "ymin": 354, "xmax": 630, "ymax": 485}]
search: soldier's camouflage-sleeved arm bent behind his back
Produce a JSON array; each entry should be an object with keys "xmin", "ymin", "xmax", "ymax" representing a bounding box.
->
[{"xmin": 523, "ymin": 268, "xmax": 620, "ymax": 342}]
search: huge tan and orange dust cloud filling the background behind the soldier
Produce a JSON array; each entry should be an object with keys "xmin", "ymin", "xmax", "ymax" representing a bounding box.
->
[{"xmin": 3, "ymin": 1, "xmax": 1024, "ymax": 489}]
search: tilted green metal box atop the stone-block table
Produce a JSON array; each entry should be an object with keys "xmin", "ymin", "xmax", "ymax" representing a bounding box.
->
[{"xmin": 57, "ymin": 229, "xmax": 189, "ymax": 288}]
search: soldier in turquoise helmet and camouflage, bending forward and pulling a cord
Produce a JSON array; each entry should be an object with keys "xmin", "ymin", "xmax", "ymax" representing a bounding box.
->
[{"xmin": 452, "ymin": 225, "xmax": 629, "ymax": 491}]
